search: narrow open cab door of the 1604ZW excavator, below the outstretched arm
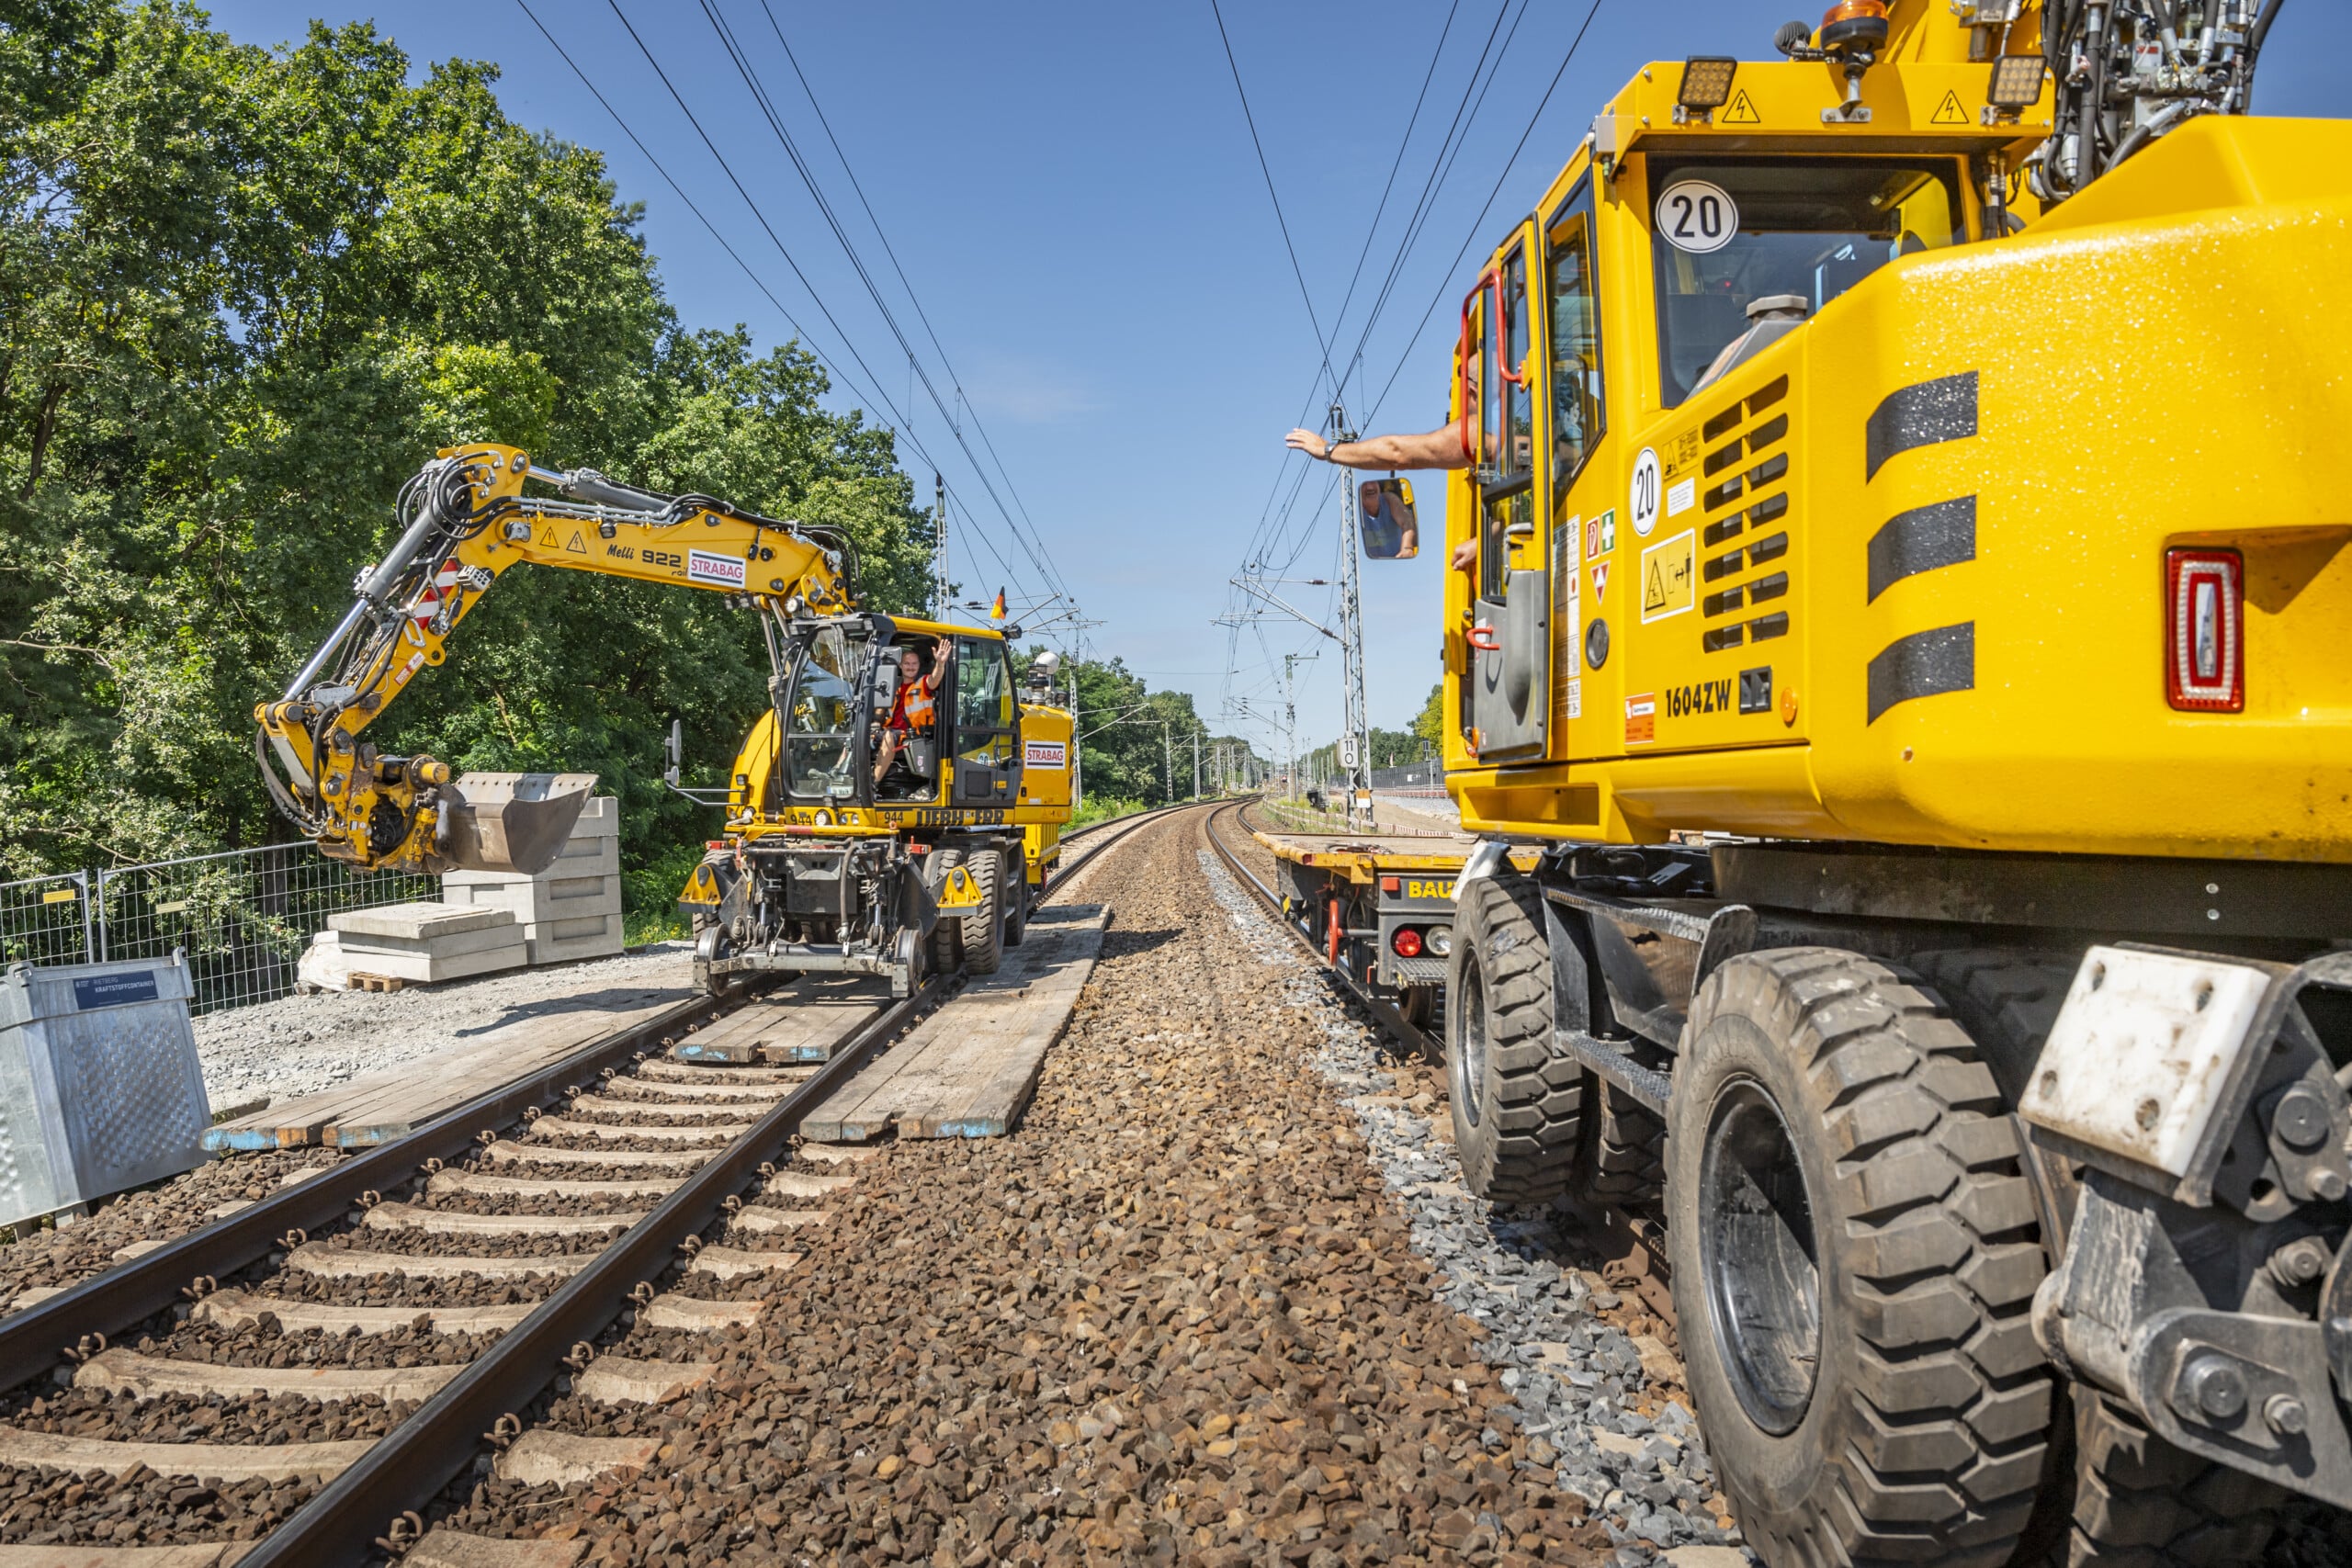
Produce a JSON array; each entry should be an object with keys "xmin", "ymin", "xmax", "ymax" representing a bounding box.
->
[{"xmin": 1463, "ymin": 232, "xmax": 1553, "ymax": 761}]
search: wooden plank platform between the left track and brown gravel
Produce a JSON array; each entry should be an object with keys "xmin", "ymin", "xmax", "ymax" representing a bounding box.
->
[{"xmin": 802, "ymin": 905, "xmax": 1110, "ymax": 1143}]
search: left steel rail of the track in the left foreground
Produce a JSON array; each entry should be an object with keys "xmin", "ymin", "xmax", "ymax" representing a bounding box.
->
[{"xmin": 0, "ymin": 997, "xmax": 722, "ymax": 1389}]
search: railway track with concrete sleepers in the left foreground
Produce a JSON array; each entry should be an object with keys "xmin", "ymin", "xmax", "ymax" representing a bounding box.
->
[{"xmin": 0, "ymin": 807, "xmax": 1194, "ymax": 1568}]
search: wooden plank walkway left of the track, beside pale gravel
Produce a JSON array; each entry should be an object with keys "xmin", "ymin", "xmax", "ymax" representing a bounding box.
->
[{"xmin": 205, "ymin": 985, "xmax": 706, "ymax": 1155}]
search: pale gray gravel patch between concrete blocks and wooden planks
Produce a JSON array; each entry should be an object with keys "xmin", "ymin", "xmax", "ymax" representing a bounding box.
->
[{"xmin": 195, "ymin": 942, "xmax": 694, "ymax": 1114}]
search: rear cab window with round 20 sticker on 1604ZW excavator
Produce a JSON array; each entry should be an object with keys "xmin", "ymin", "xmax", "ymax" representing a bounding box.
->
[{"xmin": 1649, "ymin": 157, "xmax": 1964, "ymax": 407}]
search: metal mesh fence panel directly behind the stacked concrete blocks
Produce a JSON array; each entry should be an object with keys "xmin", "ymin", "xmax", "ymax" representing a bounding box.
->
[{"xmin": 96, "ymin": 844, "xmax": 440, "ymax": 1013}]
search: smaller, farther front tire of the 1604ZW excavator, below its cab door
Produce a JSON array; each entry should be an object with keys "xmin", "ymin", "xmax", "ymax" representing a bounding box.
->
[{"xmin": 1446, "ymin": 870, "xmax": 1585, "ymax": 1203}]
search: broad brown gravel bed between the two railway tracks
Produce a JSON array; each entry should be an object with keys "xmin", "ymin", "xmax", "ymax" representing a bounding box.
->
[{"xmin": 423, "ymin": 813, "xmax": 1713, "ymax": 1568}]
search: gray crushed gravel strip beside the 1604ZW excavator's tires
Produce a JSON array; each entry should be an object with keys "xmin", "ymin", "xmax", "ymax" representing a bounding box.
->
[{"xmin": 1200, "ymin": 851, "xmax": 1747, "ymax": 1568}]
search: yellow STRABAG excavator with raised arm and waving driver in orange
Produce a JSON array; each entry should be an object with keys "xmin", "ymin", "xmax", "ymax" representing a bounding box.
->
[{"xmin": 254, "ymin": 445, "xmax": 1075, "ymax": 995}]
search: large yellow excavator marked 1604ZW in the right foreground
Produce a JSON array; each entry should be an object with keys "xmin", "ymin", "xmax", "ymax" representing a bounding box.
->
[{"xmin": 1374, "ymin": 0, "xmax": 2352, "ymax": 1568}]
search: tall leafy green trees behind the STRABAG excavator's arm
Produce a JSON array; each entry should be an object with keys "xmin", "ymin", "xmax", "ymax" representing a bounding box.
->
[{"xmin": 0, "ymin": 0, "xmax": 932, "ymax": 874}]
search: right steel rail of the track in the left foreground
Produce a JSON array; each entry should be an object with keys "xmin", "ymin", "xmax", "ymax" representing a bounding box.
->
[{"xmin": 238, "ymin": 976, "xmax": 955, "ymax": 1568}]
